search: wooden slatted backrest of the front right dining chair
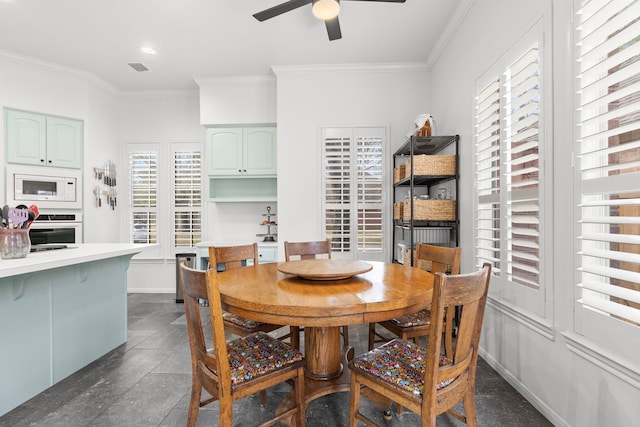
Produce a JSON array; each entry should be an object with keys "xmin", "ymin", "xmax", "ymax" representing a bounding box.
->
[{"xmin": 422, "ymin": 263, "xmax": 491, "ymax": 416}]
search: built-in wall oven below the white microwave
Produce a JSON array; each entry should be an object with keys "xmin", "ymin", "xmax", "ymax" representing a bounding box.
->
[{"xmin": 29, "ymin": 212, "xmax": 82, "ymax": 245}]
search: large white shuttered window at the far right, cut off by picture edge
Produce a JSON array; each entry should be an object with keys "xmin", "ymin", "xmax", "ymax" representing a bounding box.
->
[{"xmin": 575, "ymin": 0, "xmax": 640, "ymax": 358}]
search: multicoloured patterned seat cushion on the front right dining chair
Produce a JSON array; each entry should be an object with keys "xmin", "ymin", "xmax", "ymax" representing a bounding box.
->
[{"xmin": 353, "ymin": 339, "xmax": 455, "ymax": 396}]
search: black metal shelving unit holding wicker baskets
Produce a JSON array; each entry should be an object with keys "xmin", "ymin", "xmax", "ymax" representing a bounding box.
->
[{"xmin": 392, "ymin": 135, "xmax": 460, "ymax": 265}]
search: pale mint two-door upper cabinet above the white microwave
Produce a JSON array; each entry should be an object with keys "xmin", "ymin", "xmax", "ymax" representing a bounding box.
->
[{"xmin": 5, "ymin": 110, "xmax": 84, "ymax": 169}]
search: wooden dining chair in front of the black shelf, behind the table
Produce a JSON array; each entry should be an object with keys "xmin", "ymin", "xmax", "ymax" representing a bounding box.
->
[{"xmin": 369, "ymin": 243, "xmax": 461, "ymax": 357}]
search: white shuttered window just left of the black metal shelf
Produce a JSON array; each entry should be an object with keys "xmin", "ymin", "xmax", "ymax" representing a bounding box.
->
[{"xmin": 322, "ymin": 128, "xmax": 386, "ymax": 261}]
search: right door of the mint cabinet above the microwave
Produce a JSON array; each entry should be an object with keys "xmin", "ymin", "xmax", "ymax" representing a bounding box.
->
[{"xmin": 47, "ymin": 117, "xmax": 84, "ymax": 169}]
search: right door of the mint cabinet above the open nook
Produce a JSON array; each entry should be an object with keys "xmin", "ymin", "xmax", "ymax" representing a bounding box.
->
[{"xmin": 244, "ymin": 127, "xmax": 277, "ymax": 176}]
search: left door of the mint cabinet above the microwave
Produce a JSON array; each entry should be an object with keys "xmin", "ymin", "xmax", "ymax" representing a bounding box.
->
[{"xmin": 5, "ymin": 110, "xmax": 47, "ymax": 166}]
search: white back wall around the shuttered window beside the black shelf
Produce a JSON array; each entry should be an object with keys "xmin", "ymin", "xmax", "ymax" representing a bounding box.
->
[{"xmin": 274, "ymin": 64, "xmax": 431, "ymax": 259}]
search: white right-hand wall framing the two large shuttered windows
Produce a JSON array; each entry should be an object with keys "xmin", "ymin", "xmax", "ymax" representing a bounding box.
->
[{"xmin": 431, "ymin": 0, "xmax": 640, "ymax": 427}]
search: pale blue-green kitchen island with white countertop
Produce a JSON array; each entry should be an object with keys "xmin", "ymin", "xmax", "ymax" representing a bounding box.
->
[{"xmin": 0, "ymin": 243, "xmax": 149, "ymax": 416}]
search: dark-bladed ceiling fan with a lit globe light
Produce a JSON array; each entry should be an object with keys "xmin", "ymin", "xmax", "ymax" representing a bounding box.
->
[{"xmin": 253, "ymin": 0, "xmax": 406, "ymax": 40}]
